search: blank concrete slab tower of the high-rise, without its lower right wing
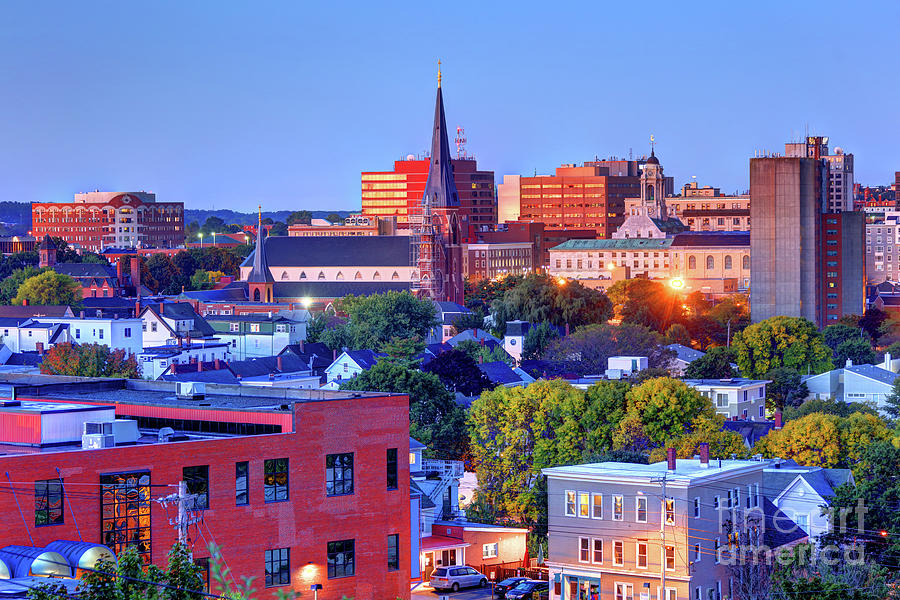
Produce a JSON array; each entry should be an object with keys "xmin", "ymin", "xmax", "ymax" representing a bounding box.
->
[{"xmin": 750, "ymin": 157, "xmax": 825, "ymax": 323}]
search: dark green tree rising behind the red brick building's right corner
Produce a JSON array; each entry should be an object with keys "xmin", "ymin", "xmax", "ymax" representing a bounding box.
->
[{"xmin": 341, "ymin": 360, "xmax": 468, "ymax": 459}]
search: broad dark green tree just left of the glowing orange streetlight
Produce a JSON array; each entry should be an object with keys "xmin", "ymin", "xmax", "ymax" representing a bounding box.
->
[{"xmin": 491, "ymin": 274, "xmax": 612, "ymax": 335}]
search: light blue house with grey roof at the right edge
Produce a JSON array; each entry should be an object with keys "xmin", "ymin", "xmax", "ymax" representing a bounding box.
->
[{"xmin": 803, "ymin": 361, "xmax": 900, "ymax": 409}]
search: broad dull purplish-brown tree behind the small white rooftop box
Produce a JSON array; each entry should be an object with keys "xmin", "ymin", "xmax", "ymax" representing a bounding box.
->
[{"xmin": 544, "ymin": 323, "xmax": 675, "ymax": 375}]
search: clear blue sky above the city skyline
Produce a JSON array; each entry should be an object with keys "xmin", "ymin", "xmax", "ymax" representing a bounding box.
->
[{"xmin": 0, "ymin": 0, "xmax": 900, "ymax": 210}]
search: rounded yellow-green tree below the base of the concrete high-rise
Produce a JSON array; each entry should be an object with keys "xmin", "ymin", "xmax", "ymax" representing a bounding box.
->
[{"xmin": 732, "ymin": 317, "xmax": 832, "ymax": 379}]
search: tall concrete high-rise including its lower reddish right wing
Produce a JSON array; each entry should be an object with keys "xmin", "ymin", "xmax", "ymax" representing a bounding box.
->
[{"xmin": 750, "ymin": 155, "xmax": 865, "ymax": 327}]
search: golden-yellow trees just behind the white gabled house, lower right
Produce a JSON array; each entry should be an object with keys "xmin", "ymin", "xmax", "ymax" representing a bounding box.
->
[{"xmin": 753, "ymin": 412, "xmax": 894, "ymax": 475}]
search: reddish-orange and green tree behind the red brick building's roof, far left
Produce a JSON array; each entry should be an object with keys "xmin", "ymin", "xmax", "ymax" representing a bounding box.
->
[{"xmin": 41, "ymin": 342, "xmax": 141, "ymax": 379}]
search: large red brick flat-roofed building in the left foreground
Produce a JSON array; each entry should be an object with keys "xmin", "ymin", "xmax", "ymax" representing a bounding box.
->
[{"xmin": 0, "ymin": 377, "xmax": 410, "ymax": 599}]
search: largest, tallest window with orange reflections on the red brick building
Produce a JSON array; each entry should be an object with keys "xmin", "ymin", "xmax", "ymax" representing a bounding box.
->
[{"xmin": 100, "ymin": 471, "xmax": 152, "ymax": 564}]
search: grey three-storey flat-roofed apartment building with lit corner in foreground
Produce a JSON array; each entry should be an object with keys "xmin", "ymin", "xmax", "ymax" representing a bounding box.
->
[{"xmin": 543, "ymin": 445, "xmax": 805, "ymax": 600}]
